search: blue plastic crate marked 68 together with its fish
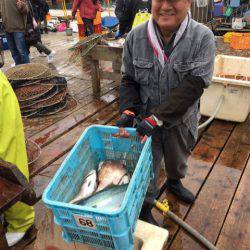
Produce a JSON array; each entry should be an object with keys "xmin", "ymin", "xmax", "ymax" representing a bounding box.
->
[{"xmin": 43, "ymin": 125, "xmax": 153, "ymax": 250}]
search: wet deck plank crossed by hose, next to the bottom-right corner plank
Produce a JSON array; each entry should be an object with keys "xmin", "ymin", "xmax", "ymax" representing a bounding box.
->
[{"xmin": 171, "ymin": 117, "xmax": 250, "ymax": 249}]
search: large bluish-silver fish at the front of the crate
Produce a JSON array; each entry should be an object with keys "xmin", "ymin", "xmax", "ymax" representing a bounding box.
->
[{"xmin": 79, "ymin": 184, "xmax": 128, "ymax": 211}]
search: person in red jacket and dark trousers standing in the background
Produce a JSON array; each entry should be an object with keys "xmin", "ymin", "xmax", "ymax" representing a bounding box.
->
[{"xmin": 71, "ymin": 0, "xmax": 102, "ymax": 36}]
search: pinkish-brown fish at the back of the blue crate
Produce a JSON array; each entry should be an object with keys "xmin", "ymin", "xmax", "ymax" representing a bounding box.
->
[{"xmin": 96, "ymin": 160, "xmax": 130, "ymax": 192}]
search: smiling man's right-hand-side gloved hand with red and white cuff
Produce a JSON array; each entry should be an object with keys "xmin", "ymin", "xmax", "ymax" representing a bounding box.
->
[{"xmin": 136, "ymin": 115, "xmax": 159, "ymax": 143}]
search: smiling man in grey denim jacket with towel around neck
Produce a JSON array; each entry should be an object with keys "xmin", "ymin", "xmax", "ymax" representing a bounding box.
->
[{"xmin": 117, "ymin": 0, "xmax": 215, "ymax": 224}]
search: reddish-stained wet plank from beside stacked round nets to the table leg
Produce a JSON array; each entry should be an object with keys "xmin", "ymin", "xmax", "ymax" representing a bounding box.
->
[{"xmin": 31, "ymin": 88, "xmax": 118, "ymax": 147}]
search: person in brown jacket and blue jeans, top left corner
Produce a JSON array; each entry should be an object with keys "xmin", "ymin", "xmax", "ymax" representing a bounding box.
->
[{"xmin": 0, "ymin": 0, "xmax": 30, "ymax": 65}]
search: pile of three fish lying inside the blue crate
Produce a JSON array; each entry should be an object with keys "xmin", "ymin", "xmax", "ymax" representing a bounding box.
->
[{"xmin": 70, "ymin": 160, "xmax": 130, "ymax": 210}]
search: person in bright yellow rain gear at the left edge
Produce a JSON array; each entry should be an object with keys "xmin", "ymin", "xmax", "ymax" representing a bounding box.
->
[{"xmin": 0, "ymin": 42, "xmax": 35, "ymax": 247}]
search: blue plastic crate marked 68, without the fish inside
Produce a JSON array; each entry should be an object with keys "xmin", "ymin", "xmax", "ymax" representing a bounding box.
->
[{"xmin": 43, "ymin": 125, "xmax": 153, "ymax": 250}]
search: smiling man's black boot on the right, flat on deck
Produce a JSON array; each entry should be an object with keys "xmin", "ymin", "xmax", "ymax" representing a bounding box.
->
[{"xmin": 166, "ymin": 179, "xmax": 195, "ymax": 204}]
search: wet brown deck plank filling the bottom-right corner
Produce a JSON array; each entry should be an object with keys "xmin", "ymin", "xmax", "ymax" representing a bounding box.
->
[{"xmin": 216, "ymin": 159, "xmax": 250, "ymax": 250}]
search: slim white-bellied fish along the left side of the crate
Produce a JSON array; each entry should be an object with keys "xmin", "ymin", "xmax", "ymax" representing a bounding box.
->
[{"xmin": 70, "ymin": 170, "xmax": 97, "ymax": 204}]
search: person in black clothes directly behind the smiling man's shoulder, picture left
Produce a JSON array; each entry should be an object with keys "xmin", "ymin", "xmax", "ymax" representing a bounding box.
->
[{"xmin": 115, "ymin": 0, "xmax": 151, "ymax": 39}]
